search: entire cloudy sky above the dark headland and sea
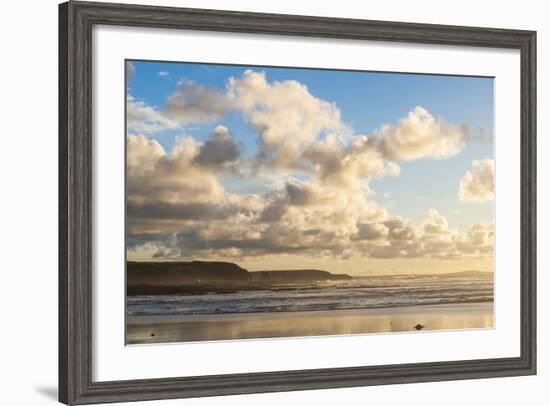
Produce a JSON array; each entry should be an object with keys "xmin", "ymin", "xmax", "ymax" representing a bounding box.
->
[{"xmin": 126, "ymin": 61, "xmax": 494, "ymax": 275}]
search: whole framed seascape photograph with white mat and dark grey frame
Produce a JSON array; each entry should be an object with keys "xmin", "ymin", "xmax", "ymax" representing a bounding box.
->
[{"xmin": 59, "ymin": 2, "xmax": 536, "ymax": 404}]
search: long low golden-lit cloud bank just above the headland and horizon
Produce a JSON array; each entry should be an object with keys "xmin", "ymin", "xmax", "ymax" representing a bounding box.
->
[{"xmin": 127, "ymin": 136, "xmax": 492, "ymax": 259}]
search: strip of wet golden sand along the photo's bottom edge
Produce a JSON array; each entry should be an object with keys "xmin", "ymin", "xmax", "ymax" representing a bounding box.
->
[{"xmin": 126, "ymin": 302, "xmax": 494, "ymax": 344}]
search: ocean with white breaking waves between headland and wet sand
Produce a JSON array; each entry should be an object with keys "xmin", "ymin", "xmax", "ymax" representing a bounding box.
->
[{"xmin": 126, "ymin": 273, "xmax": 493, "ymax": 317}]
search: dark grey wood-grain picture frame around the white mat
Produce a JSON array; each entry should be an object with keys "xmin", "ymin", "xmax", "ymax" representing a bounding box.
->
[{"xmin": 59, "ymin": 2, "xmax": 536, "ymax": 404}]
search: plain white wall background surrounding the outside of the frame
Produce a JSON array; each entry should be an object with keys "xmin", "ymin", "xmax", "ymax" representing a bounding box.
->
[{"xmin": 0, "ymin": 0, "xmax": 550, "ymax": 406}]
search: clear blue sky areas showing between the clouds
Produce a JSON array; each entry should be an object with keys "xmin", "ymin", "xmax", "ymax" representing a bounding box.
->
[{"xmin": 127, "ymin": 61, "xmax": 494, "ymax": 272}]
